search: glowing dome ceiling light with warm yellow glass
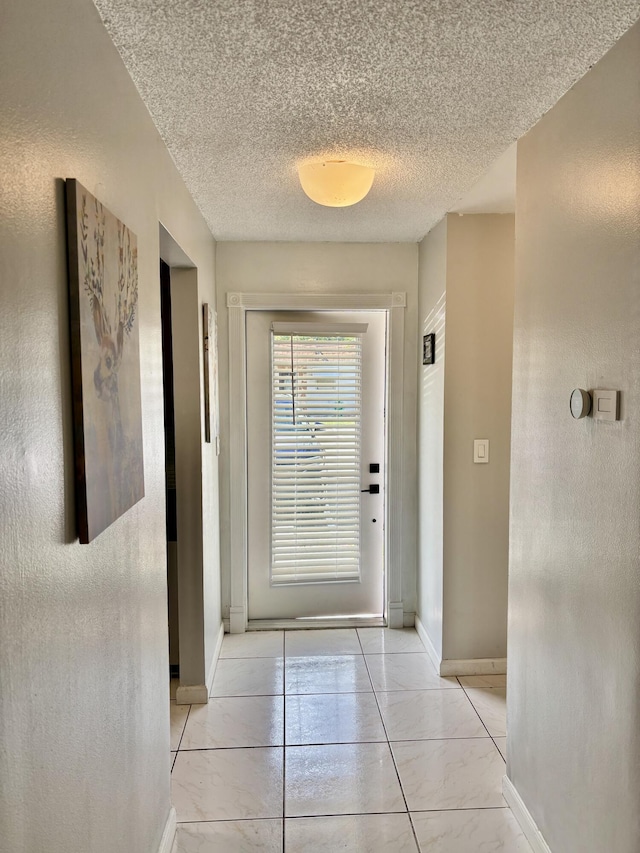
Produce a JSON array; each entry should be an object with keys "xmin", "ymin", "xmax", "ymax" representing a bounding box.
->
[{"xmin": 298, "ymin": 160, "xmax": 375, "ymax": 207}]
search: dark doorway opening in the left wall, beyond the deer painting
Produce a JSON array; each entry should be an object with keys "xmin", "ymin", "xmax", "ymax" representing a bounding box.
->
[{"xmin": 159, "ymin": 225, "xmax": 207, "ymax": 704}]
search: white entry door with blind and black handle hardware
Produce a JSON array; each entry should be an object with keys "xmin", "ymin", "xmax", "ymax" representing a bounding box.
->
[{"xmin": 246, "ymin": 311, "xmax": 387, "ymax": 620}]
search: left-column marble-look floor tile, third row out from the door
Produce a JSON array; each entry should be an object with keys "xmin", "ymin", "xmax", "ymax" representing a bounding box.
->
[{"xmin": 180, "ymin": 696, "xmax": 284, "ymax": 750}]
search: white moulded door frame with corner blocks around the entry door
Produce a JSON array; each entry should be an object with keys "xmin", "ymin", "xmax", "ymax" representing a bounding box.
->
[{"xmin": 227, "ymin": 293, "xmax": 407, "ymax": 634}]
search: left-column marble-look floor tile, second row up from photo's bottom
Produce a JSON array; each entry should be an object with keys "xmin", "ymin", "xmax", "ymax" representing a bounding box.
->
[{"xmin": 171, "ymin": 747, "xmax": 283, "ymax": 822}]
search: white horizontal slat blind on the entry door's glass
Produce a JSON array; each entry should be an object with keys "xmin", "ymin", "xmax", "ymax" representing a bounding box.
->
[{"xmin": 271, "ymin": 324, "xmax": 366, "ymax": 584}]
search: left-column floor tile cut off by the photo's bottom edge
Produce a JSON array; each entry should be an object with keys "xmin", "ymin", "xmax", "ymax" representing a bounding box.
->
[{"xmin": 171, "ymin": 820, "xmax": 282, "ymax": 853}]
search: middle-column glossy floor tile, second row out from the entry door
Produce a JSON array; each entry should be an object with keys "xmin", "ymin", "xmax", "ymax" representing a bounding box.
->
[{"xmin": 284, "ymin": 655, "xmax": 372, "ymax": 694}]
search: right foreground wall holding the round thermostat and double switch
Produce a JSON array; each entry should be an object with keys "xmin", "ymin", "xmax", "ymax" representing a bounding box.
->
[{"xmin": 508, "ymin": 24, "xmax": 640, "ymax": 853}]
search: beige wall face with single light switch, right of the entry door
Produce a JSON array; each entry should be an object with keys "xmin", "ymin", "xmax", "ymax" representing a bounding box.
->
[{"xmin": 442, "ymin": 214, "xmax": 515, "ymax": 660}]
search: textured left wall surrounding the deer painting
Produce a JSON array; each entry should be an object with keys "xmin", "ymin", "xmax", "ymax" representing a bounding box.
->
[{"xmin": 0, "ymin": 0, "xmax": 220, "ymax": 853}]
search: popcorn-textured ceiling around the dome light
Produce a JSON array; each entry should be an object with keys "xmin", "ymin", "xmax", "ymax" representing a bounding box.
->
[{"xmin": 95, "ymin": 0, "xmax": 640, "ymax": 241}]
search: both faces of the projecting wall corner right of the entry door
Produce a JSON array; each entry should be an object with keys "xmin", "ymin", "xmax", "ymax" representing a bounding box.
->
[{"xmin": 419, "ymin": 214, "xmax": 514, "ymax": 661}]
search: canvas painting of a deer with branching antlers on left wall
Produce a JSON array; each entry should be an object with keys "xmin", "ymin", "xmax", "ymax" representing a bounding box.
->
[{"xmin": 66, "ymin": 178, "xmax": 144, "ymax": 543}]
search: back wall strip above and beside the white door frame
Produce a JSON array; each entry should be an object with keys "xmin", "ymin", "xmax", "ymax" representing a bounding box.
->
[{"xmin": 216, "ymin": 243, "xmax": 419, "ymax": 618}]
